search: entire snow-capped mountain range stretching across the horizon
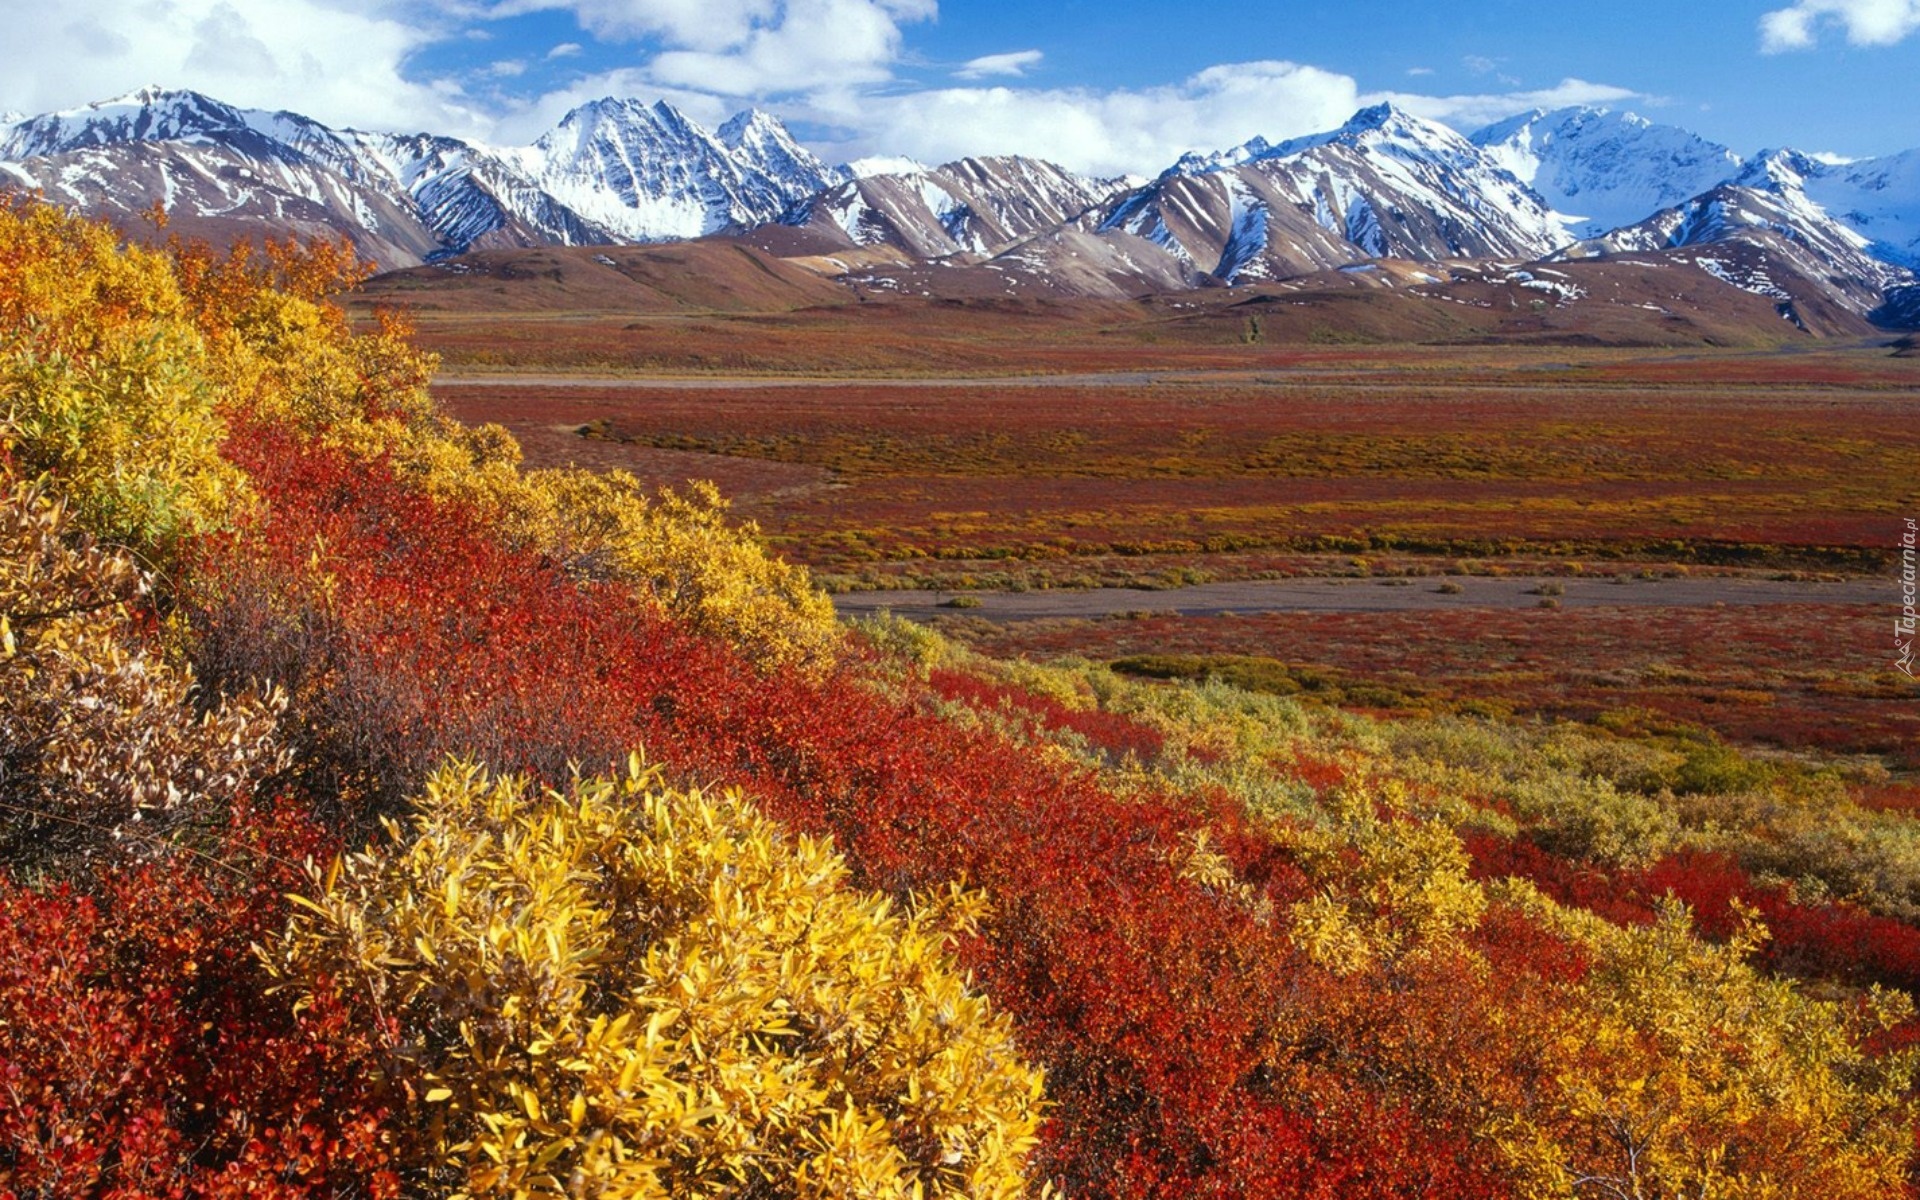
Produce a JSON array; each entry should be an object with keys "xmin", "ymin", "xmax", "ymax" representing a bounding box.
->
[{"xmin": 0, "ymin": 88, "xmax": 1920, "ymax": 326}]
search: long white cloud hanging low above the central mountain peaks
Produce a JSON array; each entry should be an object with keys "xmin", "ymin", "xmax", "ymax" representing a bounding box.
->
[{"xmin": 804, "ymin": 61, "xmax": 1359, "ymax": 175}]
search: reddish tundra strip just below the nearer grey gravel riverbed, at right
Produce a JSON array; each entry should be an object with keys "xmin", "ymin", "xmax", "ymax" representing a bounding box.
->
[{"xmin": 952, "ymin": 602, "xmax": 1920, "ymax": 764}]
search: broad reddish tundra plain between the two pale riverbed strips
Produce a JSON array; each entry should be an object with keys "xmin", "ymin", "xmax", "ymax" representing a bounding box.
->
[{"xmin": 438, "ymin": 361, "xmax": 1920, "ymax": 572}]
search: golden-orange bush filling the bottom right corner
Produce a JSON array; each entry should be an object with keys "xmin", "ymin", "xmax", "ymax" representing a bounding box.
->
[{"xmin": 1492, "ymin": 883, "xmax": 1916, "ymax": 1200}]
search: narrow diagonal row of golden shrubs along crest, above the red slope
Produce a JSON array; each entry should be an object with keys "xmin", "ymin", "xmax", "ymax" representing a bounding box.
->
[{"xmin": 182, "ymin": 244, "xmax": 837, "ymax": 668}]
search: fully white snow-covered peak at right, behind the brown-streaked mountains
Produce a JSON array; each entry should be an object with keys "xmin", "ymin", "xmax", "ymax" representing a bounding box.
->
[{"xmin": 1471, "ymin": 108, "xmax": 1743, "ymax": 238}]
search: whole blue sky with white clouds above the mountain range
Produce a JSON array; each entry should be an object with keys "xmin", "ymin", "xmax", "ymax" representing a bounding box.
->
[{"xmin": 0, "ymin": 0, "xmax": 1920, "ymax": 173}]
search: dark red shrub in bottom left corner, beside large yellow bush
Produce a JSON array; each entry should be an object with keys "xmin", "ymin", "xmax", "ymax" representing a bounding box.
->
[{"xmin": 0, "ymin": 794, "xmax": 403, "ymax": 1200}]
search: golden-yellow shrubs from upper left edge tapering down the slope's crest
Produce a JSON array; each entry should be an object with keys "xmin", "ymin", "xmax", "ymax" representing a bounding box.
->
[{"xmin": 0, "ymin": 202, "xmax": 839, "ymax": 666}]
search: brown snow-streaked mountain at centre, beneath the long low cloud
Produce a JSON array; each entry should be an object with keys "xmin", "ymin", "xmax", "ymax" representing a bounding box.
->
[{"xmin": 785, "ymin": 156, "xmax": 1108, "ymax": 259}]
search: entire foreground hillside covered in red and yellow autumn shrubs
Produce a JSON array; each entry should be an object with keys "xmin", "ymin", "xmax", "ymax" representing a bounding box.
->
[{"xmin": 0, "ymin": 198, "xmax": 1916, "ymax": 1200}]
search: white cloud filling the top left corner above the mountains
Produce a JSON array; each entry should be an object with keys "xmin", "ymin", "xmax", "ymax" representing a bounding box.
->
[{"xmin": 0, "ymin": 0, "xmax": 484, "ymax": 132}]
